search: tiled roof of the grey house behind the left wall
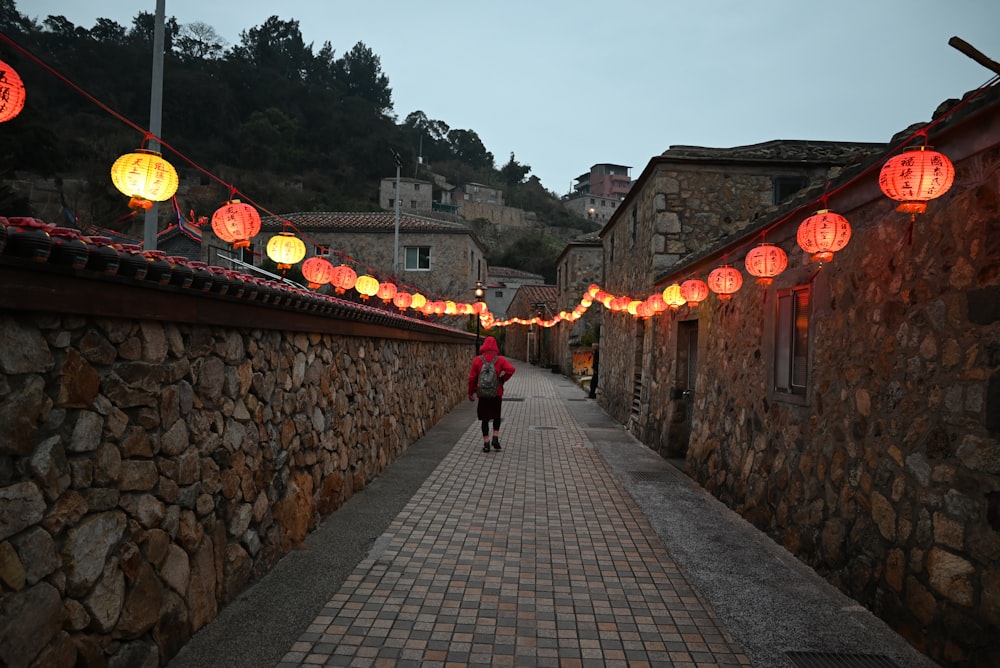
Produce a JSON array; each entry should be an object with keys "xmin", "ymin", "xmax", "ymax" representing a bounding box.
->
[{"xmin": 261, "ymin": 211, "xmax": 475, "ymax": 236}]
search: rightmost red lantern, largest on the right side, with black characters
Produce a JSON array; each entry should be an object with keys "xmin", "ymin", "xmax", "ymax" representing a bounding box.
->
[{"xmin": 878, "ymin": 146, "xmax": 955, "ymax": 214}]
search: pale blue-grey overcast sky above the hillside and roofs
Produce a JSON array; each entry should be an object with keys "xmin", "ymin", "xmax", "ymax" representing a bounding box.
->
[{"xmin": 16, "ymin": 0, "xmax": 1000, "ymax": 195}]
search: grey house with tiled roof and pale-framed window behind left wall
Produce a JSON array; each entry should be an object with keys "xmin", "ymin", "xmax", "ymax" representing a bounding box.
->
[{"xmin": 205, "ymin": 212, "xmax": 487, "ymax": 301}]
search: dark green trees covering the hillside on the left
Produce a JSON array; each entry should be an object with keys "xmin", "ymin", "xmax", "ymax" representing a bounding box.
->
[{"xmin": 0, "ymin": 0, "xmax": 597, "ymax": 281}]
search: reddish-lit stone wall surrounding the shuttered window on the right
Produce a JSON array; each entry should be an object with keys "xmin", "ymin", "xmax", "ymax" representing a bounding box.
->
[{"xmin": 632, "ymin": 113, "xmax": 1000, "ymax": 668}]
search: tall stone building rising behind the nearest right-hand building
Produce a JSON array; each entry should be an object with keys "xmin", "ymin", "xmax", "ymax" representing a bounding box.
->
[{"xmin": 600, "ymin": 141, "xmax": 884, "ymax": 424}]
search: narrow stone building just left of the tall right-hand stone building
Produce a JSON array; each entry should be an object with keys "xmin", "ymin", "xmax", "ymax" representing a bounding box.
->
[{"xmin": 551, "ymin": 236, "xmax": 604, "ymax": 375}]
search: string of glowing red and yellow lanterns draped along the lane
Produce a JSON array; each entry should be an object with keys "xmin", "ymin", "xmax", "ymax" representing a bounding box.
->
[{"xmin": 0, "ymin": 36, "xmax": 968, "ymax": 328}]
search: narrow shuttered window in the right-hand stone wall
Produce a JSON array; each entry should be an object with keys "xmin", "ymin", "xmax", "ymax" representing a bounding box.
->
[{"xmin": 774, "ymin": 286, "xmax": 811, "ymax": 398}]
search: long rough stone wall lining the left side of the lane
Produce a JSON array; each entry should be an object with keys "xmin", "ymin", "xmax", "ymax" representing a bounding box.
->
[{"xmin": 0, "ymin": 262, "xmax": 472, "ymax": 668}]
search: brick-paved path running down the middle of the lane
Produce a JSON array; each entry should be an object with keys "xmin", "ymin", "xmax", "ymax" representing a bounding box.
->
[{"xmin": 279, "ymin": 371, "xmax": 750, "ymax": 667}]
